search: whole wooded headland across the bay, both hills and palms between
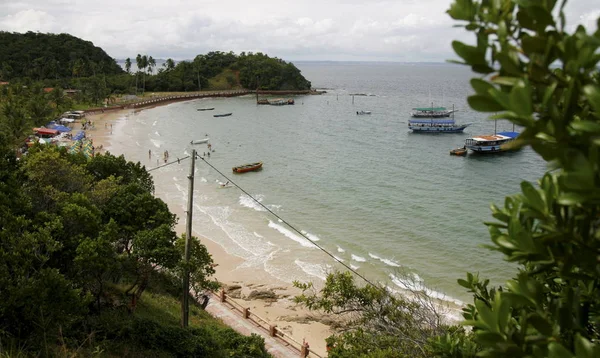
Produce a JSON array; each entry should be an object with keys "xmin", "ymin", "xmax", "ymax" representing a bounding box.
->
[{"xmin": 0, "ymin": 32, "xmax": 311, "ymax": 99}]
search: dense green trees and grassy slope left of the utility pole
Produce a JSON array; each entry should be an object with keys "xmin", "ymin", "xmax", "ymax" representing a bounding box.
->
[{"xmin": 0, "ymin": 121, "xmax": 268, "ymax": 357}]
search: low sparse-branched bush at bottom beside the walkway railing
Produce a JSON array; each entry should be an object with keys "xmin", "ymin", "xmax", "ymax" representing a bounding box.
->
[{"xmin": 294, "ymin": 272, "xmax": 478, "ymax": 358}]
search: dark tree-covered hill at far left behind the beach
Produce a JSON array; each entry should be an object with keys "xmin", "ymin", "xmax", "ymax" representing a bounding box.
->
[{"xmin": 0, "ymin": 31, "xmax": 123, "ymax": 81}]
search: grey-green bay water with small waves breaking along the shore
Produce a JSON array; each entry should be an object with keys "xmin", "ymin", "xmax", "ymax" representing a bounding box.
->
[{"xmin": 110, "ymin": 62, "xmax": 545, "ymax": 301}]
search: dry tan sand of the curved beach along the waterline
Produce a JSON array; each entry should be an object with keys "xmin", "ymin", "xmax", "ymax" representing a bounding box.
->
[{"xmin": 85, "ymin": 108, "xmax": 332, "ymax": 355}]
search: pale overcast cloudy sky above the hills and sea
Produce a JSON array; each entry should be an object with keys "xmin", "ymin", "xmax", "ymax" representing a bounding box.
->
[{"xmin": 0, "ymin": 0, "xmax": 600, "ymax": 62}]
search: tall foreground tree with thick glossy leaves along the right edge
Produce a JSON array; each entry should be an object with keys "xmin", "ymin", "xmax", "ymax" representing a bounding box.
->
[{"xmin": 448, "ymin": 0, "xmax": 600, "ymax": 357}]
